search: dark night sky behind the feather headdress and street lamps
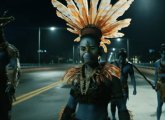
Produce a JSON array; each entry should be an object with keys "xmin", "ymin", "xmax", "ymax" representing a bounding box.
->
[{"xmin": 0, "ymin": 0, "xmax": 165, "ymax": 62}]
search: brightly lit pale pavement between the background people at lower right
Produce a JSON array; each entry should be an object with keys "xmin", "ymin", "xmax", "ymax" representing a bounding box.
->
[{"xmin": 127, "ymin": 86, "xmax": 165, "ymax": 120}]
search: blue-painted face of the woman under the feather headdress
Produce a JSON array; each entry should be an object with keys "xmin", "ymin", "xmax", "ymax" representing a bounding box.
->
[{"xmin": 80, "ymin": 37, "xmax": 100, "ymax": 64}]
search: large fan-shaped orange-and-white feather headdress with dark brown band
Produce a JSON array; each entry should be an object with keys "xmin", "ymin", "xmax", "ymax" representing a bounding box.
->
[{"xmin": 52, "ymin": 0, "xmax": 134, "ymax": 52}]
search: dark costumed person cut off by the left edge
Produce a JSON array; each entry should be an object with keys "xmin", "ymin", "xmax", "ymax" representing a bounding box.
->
[{"xmin": 0, "ymin": 10, "xmax": 20, "ymax": 120}]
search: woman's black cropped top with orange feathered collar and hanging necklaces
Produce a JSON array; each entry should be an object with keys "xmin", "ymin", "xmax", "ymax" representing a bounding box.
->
[{"xmin": 64, "ymin": 64, "xmax": 120, "ymax": 104}]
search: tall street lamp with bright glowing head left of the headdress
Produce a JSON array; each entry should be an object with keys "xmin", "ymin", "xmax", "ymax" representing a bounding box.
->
[{"xmin": 38, "ymin": 27, "xmax": 56, "ymax": 66}]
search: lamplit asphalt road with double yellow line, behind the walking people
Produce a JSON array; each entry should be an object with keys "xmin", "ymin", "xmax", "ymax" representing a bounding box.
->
[{"xmin": 12, "ymin": 65, "xmax": 165, "ymax": 120}]
